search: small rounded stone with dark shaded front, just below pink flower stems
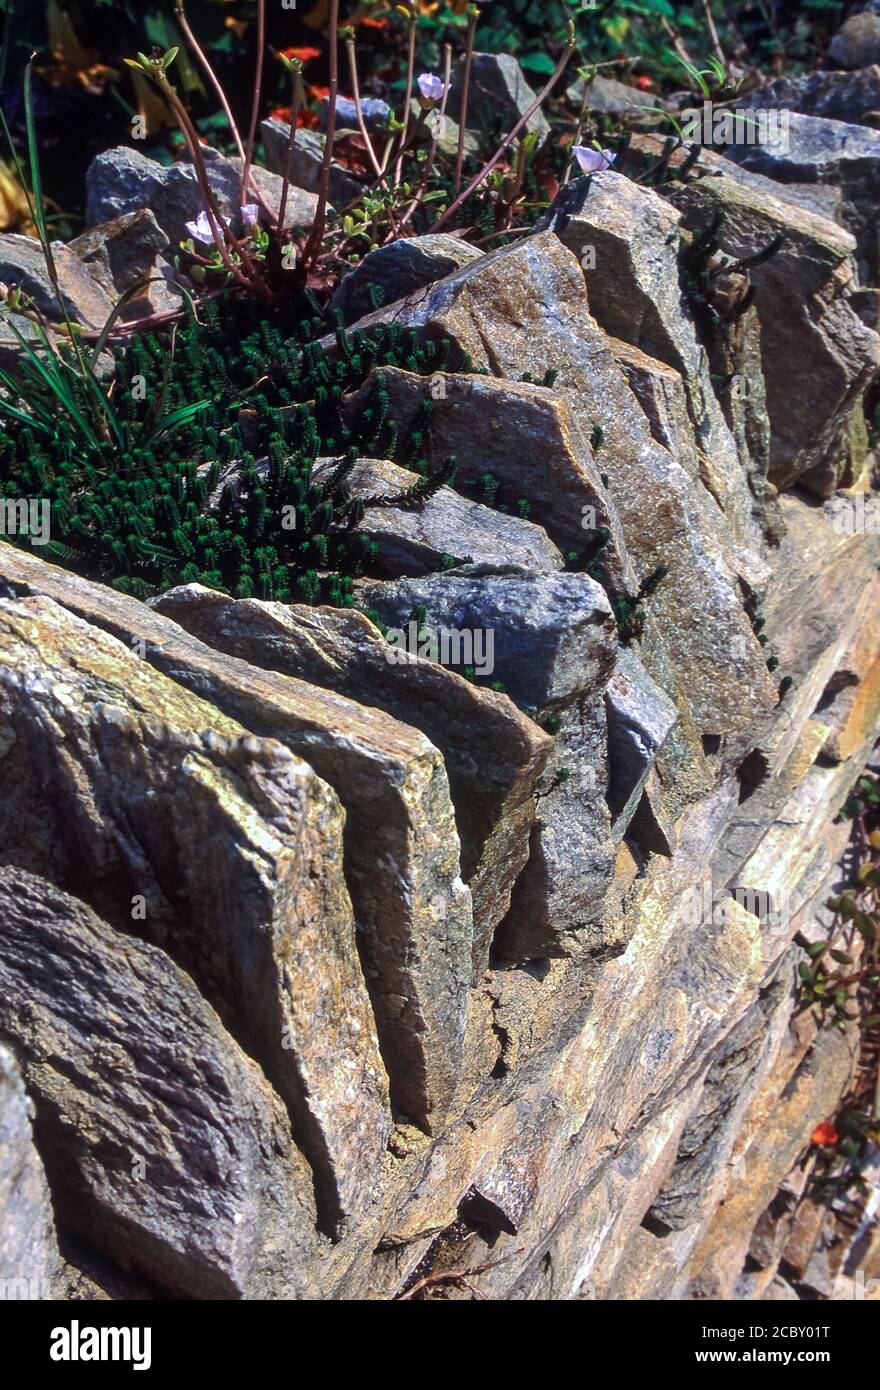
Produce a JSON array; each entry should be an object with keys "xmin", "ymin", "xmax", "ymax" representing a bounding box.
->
[{"xmin": 329, "ymin": 234, "xmax": 482, "ymax": 324}]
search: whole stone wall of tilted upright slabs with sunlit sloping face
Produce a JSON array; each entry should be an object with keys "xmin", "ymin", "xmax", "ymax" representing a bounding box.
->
[{"xmin": 0, "ymin": 102, "xmax": 880, "ymax": 1300}]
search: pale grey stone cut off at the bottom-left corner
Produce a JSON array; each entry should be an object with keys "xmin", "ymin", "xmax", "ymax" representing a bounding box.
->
[{"xmin": 0, "ymin": 1045, "xmax": 60, "ymax": 1301}]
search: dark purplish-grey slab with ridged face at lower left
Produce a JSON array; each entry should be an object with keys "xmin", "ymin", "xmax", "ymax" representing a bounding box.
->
[{"xmin": 0, "ymin": 867, "xmax": 317, "ymax": 1298}]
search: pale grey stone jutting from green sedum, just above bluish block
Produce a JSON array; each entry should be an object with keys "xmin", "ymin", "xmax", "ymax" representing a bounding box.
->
[{"xmin": 311, "ymin": 459, "xmax": 564, "ymax": 575}]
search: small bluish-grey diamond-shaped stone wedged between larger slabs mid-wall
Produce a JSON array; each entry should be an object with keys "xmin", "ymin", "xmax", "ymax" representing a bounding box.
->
[{"xmin": 605, "ymin": 646, "xmax": 678, "ymax": 840}]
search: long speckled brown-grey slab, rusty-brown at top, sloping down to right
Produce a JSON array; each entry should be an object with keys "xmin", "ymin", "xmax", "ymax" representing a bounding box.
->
[{"xmin": 336, "ymin": 232, "xmax": 776, "ymax": 734}]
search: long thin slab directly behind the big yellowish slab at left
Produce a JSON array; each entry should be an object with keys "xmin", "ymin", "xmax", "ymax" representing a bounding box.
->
[{"xmin": 0, "ymin": 546, "xmax": 473, "ymax": 1139}]
